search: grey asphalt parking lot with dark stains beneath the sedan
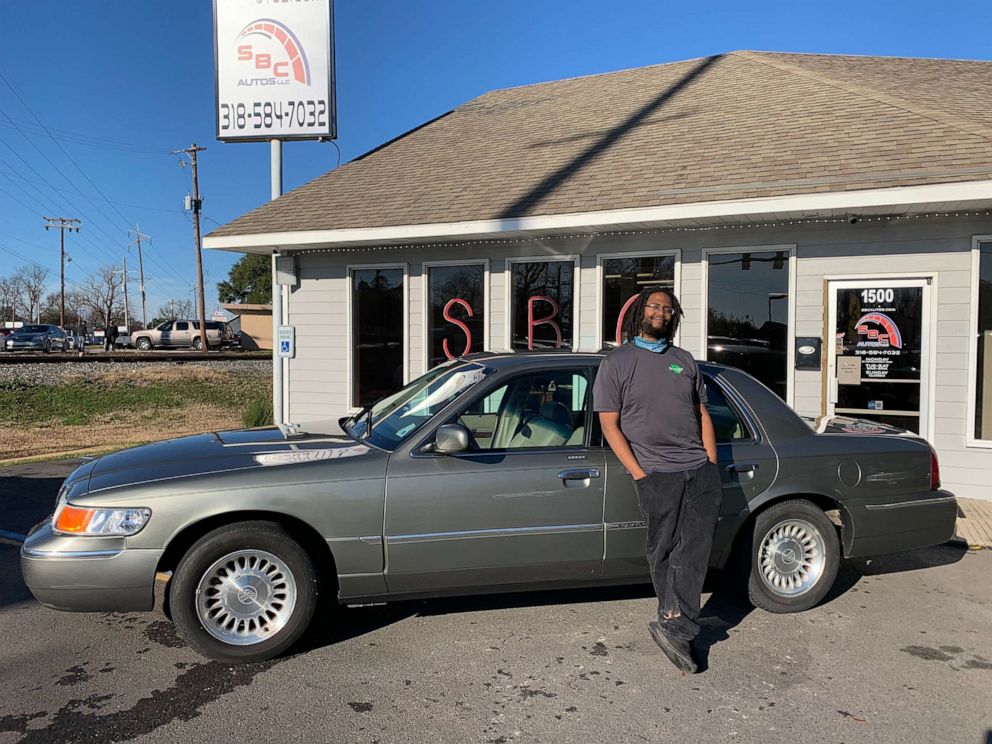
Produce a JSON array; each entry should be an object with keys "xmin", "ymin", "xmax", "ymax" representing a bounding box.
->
[{"xmin": 0, "ymin": 461, "xmax": 992, "ymax": 744}]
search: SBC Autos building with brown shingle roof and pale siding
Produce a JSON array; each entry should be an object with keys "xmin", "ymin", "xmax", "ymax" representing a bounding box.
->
[{"xmin": 205, "ymin": 52, "xmax": 992, "ymax": 499}]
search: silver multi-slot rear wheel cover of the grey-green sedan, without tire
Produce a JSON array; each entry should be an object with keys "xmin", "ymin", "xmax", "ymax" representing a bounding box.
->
[{"xmin": 758, "ymin": 519, "xmax": 826, "ymax": 598}]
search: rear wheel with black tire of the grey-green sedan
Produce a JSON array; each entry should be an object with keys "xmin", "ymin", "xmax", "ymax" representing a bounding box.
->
[{"xmin": 747, "ymin": 499, "xmax": 840, "ymax": 614}]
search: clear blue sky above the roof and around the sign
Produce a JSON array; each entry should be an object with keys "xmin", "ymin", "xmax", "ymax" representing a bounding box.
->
[{"xmin": 0, "ymin": 0, "xmax": 992, "ymax": 322}]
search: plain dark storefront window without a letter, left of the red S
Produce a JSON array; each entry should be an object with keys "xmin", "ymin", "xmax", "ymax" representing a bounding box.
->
[{"xmin": 351, "ymin": 268, "xmax": 406, "ymax": 406}]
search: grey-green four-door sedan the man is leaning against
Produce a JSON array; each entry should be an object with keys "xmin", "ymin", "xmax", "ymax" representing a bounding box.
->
[{"xmin": 21, "ymin": 353, "xmax": 957, "ymax": 662}]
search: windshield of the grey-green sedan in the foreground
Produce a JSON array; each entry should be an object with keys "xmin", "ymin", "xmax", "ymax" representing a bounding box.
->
[{"xmin": 345, "ymin": 362, "xmax": 495, "ymax": 450}]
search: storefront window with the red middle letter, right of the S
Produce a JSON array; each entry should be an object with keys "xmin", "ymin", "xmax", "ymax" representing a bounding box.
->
[{"xmin": 510, "ymin": 261, "xmax": 575, "ymax": 349}]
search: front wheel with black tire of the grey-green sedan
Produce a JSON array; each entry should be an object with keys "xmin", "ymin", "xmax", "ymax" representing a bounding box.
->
[{"xmin": 169, "ymin": 522, "xmax": 318, "ymax": 664}]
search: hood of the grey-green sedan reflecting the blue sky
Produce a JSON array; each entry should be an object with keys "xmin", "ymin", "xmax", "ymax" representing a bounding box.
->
[{"xmin": 80, "ymin": 427, "xmax": 378, "ymax": 493}]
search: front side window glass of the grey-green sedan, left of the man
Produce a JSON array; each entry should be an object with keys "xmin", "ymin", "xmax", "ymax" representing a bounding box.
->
[{"xmin": 455, "ymin": 369, "xmax": 590, "ymax": 451}]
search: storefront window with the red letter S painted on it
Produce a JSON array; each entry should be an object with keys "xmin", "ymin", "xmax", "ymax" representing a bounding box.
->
[{"xmin": 427, "ymin": 264, "xmax": 485, "ymax": 367}]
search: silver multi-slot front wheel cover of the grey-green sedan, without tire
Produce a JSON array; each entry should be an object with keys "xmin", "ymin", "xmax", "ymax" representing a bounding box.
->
[{"xmin": 196, "ymin": 550, "xmax": 296, "ymax": 646}]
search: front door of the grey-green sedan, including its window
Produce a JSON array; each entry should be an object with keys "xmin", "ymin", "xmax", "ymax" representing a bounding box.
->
[{"xmin": 384, "ymin": 366, "xmax": 603, "ymax": 592}]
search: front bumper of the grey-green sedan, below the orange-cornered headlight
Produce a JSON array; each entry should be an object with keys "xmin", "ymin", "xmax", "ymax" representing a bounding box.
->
[{"xmin": 21, "ymin": 520, "xmax": 163, "ymax": 612}]
